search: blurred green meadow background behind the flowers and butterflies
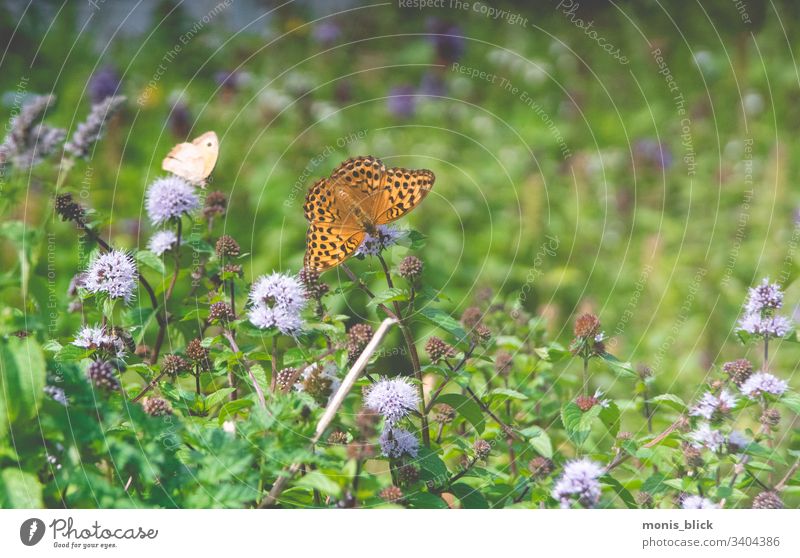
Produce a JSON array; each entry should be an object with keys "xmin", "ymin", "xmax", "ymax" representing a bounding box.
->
[{"xmin": 0, "ymin": 0, "xmax": 800, "ymax": 406}]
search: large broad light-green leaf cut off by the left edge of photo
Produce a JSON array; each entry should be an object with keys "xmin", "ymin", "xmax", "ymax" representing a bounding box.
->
[{"xmin": 0, "ymin": 337, "xmax": 46, "ymax": 435}]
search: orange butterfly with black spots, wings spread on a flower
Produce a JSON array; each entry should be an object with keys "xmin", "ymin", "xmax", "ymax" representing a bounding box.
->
[{"xmin": 303, "ymin": 156, "xmax": 436, "ymax": 272}]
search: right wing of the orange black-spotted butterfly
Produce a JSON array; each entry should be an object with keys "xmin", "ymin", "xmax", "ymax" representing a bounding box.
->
[{"xmin": 372, "ymin": 168, "xmax": 436, "ymax": 225}]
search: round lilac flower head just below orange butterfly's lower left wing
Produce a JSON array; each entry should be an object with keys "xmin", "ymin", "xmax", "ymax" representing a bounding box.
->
[{"xmin": 248, "ymin": 273, "xmax": 306, "ymax": 335}]
